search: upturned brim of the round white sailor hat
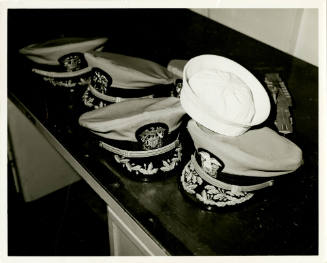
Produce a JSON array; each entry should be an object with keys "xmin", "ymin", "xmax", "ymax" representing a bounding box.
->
[{"xmin": 180, "ymin": 55, "xmax": 270, "ymax": 136}]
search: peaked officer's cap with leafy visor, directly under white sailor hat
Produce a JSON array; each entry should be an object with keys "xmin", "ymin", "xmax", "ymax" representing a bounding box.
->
[{"xmin": 180, "ymin": 120, "xmax": 303, "ymax": 209}]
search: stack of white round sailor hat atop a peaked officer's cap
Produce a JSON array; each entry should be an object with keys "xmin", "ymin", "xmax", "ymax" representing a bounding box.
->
[{"xmin": 180, "ymin": 55, "xmax": 302, "ymax": 209}]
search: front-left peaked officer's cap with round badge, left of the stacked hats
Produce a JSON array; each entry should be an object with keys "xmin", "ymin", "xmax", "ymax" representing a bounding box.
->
[{"xmin": 79, "ymin": 97, "xmax": 185, "ymax": 180}]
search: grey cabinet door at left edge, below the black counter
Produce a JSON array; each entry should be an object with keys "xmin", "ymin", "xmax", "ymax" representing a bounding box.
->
[{"xmin": 8, "ymin": 100, "xmax": 80, "ymax": 202}]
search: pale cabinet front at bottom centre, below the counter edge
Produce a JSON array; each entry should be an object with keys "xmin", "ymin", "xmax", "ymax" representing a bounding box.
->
[{"xmin": 107, "ymin": 205, "xmax": 168, "ymax": 256}]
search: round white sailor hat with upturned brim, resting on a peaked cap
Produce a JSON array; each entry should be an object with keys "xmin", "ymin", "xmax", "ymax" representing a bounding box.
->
[{"xmin": 180, "ymin": 55, "xmax": 270, "ymax": 136}]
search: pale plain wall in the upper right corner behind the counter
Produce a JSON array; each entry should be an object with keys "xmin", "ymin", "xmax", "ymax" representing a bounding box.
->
[{"xmin": 192, "ymin": 8, "xmax": 318, "ymax": 66}]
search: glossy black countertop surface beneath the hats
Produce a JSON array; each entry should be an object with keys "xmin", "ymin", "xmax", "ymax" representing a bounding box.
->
[{"xmin": 8, "ymin": 9, "xmax": 318, "ymax": 255}]
